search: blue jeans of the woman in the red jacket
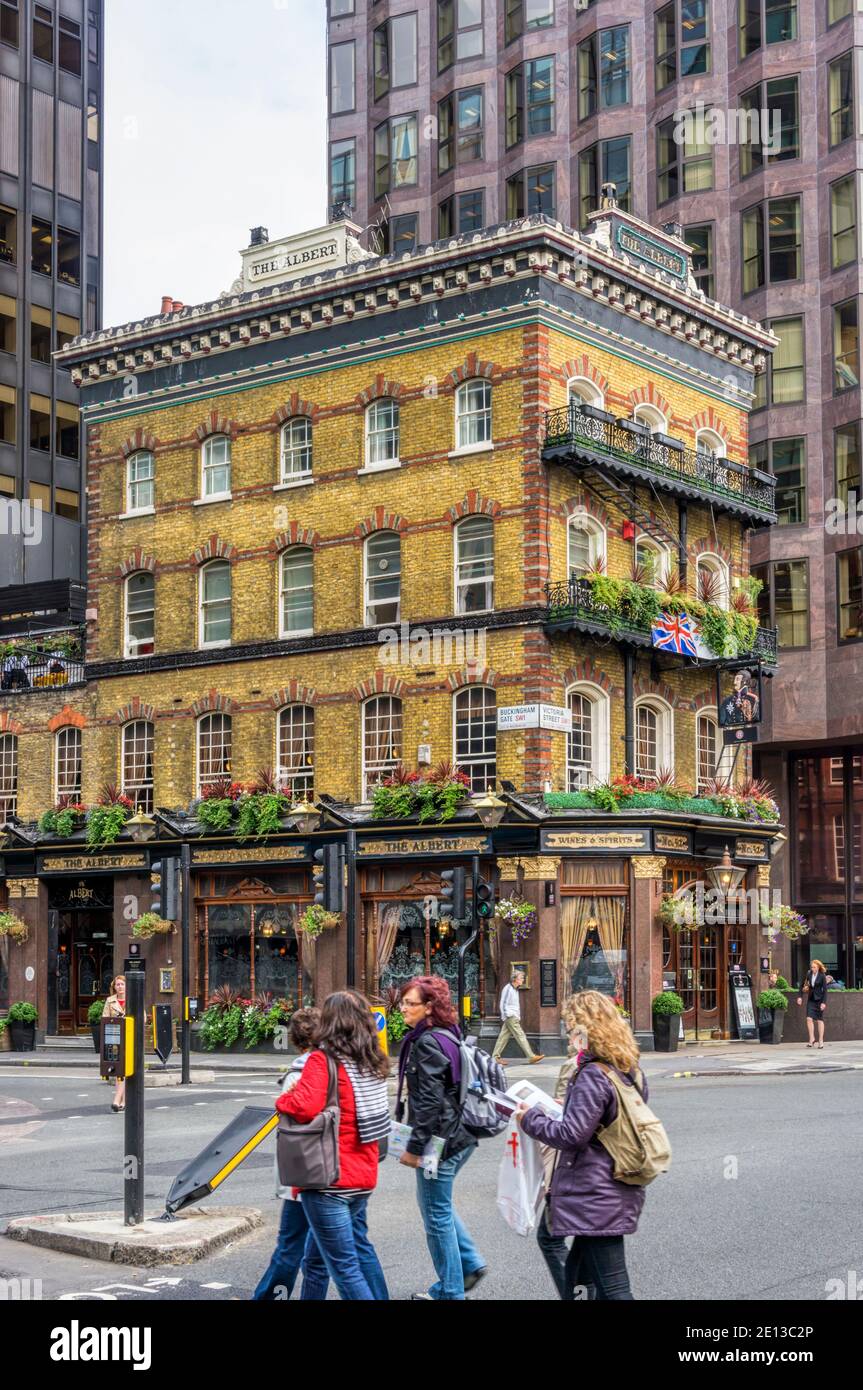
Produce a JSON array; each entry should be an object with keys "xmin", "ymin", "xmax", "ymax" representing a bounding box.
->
[{"xmin": 300, "ymin": 1191, "xmax": 389, "ymax": 1302}]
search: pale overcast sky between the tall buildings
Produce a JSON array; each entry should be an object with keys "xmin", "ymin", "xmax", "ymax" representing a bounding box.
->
[{"xmin": 103, "ymin": 0, "xmax": 327, "ymax": 325}]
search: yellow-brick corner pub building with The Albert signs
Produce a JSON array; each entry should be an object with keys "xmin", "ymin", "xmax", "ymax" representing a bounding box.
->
[{"xmin": 0, "ymin": 197, "xmax": 780, "ymax": 1051}]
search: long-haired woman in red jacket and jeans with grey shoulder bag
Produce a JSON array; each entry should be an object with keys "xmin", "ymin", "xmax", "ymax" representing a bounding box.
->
[{"xmin": 275, "ymin": 990, "xmax": 391, "ymax": 1302}]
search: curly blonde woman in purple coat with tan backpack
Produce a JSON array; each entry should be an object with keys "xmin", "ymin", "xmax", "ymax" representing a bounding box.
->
[{"xmin": 516, "ymin": 990, "xmax": 648, "ymax": 1301}]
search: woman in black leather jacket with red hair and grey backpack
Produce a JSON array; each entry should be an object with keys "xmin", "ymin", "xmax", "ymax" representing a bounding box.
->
[{"xmin": 396, "ymin": 976, "xmax": 485, "ymax": 1302}]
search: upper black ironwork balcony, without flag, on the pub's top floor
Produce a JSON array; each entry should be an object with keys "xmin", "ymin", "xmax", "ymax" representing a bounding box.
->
[{"xmin": 542, "ymin": 402, "xmax": 777, "ymax": 525}]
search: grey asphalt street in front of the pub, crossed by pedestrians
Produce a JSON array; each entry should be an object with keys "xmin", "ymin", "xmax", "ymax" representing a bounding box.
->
[{"xmin": 0, "ymin": 1066, "xmax": 863, "ymax": 1301}]
